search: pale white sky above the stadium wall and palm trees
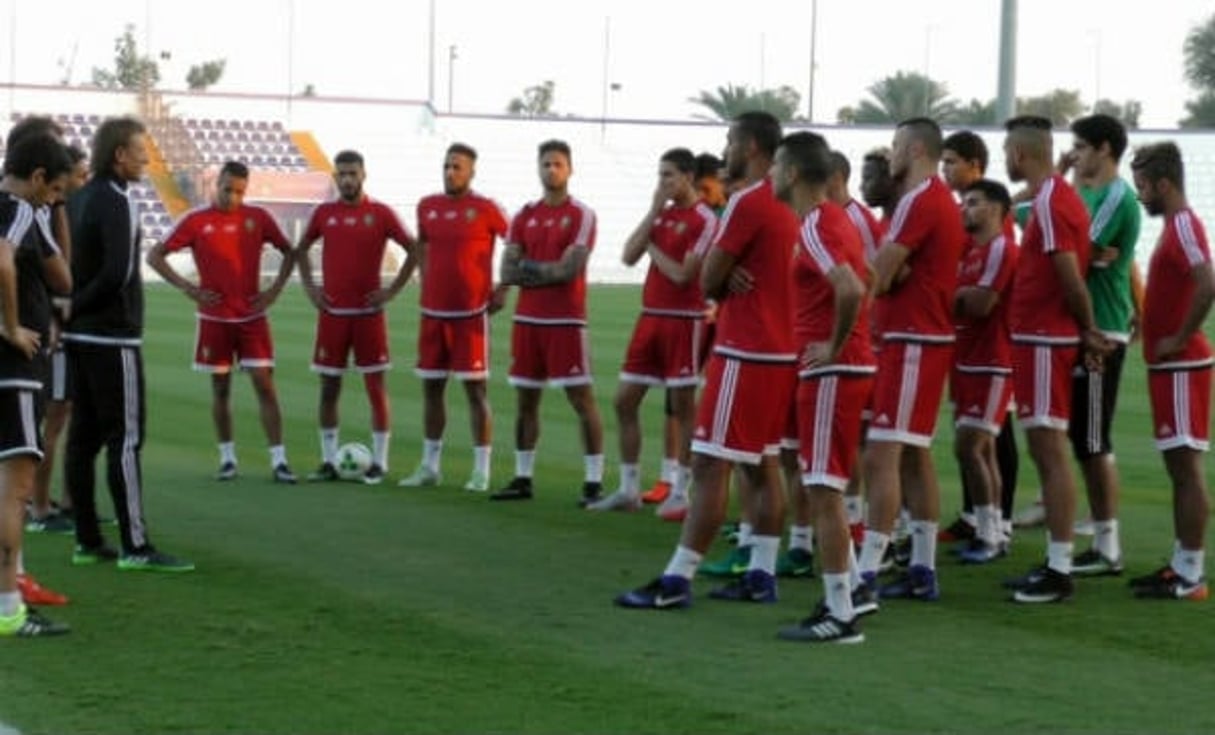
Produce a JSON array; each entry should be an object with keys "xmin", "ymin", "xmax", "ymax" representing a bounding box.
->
[{"xmin": 0, "ymin": 0, "xmax": 1215, "ymax": 128}]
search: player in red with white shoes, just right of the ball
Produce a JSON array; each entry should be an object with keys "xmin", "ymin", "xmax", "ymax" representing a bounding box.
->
[{"xmin": 400, "ymin": 143, "xmax": 507, "ymax": 492}]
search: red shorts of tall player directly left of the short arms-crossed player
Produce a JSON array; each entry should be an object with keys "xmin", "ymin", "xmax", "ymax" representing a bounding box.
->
[{"xmin": 869, "ymin": 340, "xmax": 954, "ymax": 447}]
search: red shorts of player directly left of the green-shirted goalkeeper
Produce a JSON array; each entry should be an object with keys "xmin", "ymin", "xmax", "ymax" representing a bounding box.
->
[{"xmin": 1012, "ymin": 341, "xmax": 1080, "ymax": 431}]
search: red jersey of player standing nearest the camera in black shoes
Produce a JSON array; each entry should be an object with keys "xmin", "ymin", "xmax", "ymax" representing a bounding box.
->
[{"xmin": 793, "ymin": 202, "xmax": 877, "ymax": 377}]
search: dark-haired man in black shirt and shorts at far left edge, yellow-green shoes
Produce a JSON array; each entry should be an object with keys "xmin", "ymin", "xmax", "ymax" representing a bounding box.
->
[{"xmin": 0, "ymin": 134, "xmax": 72, "ymax": 638}]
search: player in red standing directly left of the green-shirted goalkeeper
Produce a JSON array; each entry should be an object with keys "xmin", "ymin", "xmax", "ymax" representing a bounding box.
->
[{"xmin": 1004, "ymin": 115, "xmax": 1106, "ymax": 603}]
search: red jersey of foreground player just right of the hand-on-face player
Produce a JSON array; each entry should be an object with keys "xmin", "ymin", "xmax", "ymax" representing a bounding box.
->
[{"xmin": 713, "ymin": 179, "xmax": 797, "ymax": 362}]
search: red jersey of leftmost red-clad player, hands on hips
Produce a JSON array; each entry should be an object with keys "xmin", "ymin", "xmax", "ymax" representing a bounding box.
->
[{"xmin": 164, "ymin": 205, "xmax": 292, "ymax": 322}]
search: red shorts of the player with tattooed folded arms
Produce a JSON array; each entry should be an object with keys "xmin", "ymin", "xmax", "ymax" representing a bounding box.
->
[{"xmin": 507, "ymin": 322, "xmax": 590, "ymax": 388}]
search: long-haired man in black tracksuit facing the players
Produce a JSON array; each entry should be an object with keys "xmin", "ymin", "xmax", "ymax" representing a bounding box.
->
[{"xmin": 63, "ymin": 117, "xmax": 194, "ymax": 572}]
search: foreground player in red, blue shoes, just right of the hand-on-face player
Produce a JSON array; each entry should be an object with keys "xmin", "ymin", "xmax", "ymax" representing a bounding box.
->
[{"xmin": 616, "ymin": 112, "xmax": 797, "ymax": 609}]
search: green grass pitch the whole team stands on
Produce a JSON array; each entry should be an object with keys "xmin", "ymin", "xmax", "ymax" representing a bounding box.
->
[{"xmin": 0, "ymin": 281, "xmax": 1215, "ymax": 734}]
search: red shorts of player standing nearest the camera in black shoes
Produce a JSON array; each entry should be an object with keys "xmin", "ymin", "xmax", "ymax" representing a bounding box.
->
[{"xmin": 797, "ymin": 373, "xmax": 874, "ymax": 492}]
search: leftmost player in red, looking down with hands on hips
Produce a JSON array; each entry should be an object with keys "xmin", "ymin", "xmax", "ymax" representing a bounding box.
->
[{"xmin": 147, "ymin": 160, "xmax": 295, "ymax": 484}]
